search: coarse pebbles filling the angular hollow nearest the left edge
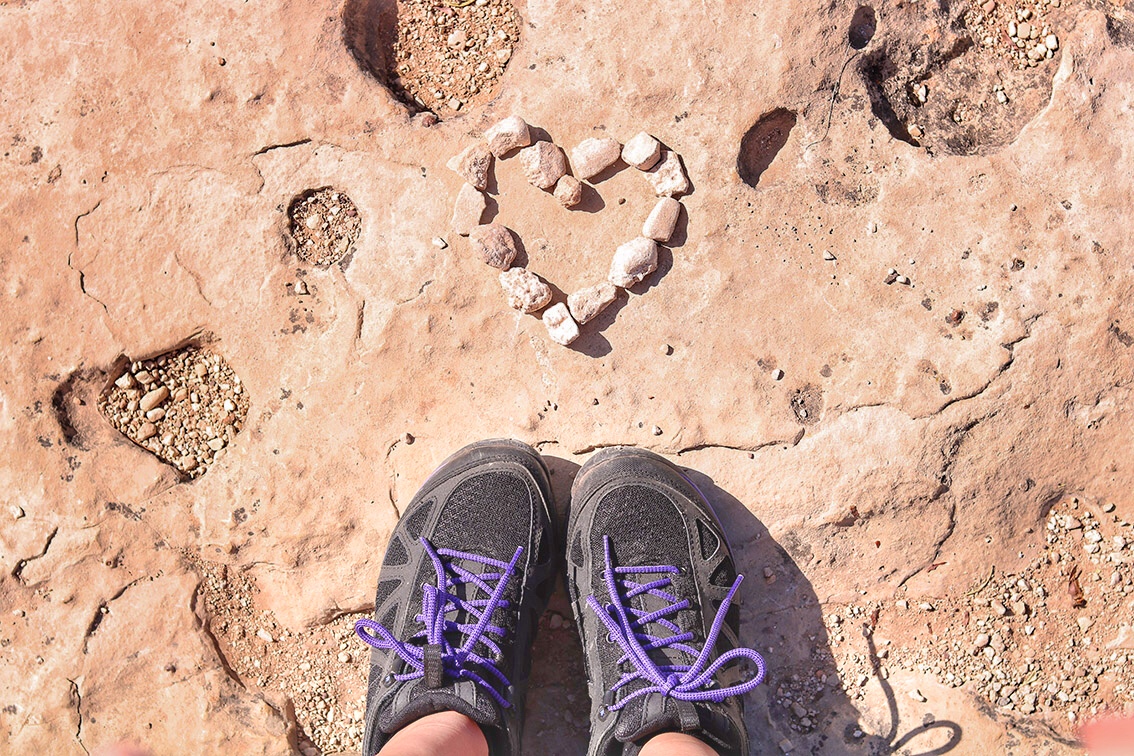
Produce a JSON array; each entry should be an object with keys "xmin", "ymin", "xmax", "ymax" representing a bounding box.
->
[{"xmin": 99, "ymin": 347, "xmax": 248, "ymax": 477}]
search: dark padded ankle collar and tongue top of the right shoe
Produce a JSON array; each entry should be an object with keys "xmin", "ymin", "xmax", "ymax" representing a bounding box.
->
[{"xmin": 615, "ymin": 693, "xmax": 739, "ymax": 753}]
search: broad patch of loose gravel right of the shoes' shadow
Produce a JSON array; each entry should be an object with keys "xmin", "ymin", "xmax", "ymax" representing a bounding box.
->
[{"xmin": 826, "ymin": 496, "xmax": 1134, "ymax": 734}]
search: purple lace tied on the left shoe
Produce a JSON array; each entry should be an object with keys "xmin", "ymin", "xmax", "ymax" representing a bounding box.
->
[{"xmin": 355, "ymin": 537, "xmax": 524, "ymax": 708}]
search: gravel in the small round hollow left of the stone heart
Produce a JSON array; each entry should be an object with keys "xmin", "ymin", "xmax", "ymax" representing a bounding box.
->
[{"xmin": 289, "ymin": 187, "xmax": 362, "ymax": 265}]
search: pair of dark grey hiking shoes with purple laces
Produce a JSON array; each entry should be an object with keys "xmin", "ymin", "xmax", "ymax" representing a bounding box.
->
[{"xmin": 355, "ymin": 440, "xmax": 764, "ymax": 756}]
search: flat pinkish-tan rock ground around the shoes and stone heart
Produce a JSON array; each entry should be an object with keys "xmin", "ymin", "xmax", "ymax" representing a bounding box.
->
[{"xmin": 0, "ymin": 0, "xmax": 1134, "ymax": 754}]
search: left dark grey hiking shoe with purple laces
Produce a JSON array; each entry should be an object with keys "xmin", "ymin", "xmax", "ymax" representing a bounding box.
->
[{"xmin": 355, "ymin": 440, "xmax": 555, "ymax": 756}]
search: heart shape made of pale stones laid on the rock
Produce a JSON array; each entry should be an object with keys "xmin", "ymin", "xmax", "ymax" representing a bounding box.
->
[{"xmin": 448, "ymin": 116, "xmax": 689, "ymax": 346}]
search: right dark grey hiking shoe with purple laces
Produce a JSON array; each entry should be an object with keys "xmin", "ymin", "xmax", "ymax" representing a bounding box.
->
[{"xmin": 567, "ymin": 448, "xmax": 764, "ymax": 756}]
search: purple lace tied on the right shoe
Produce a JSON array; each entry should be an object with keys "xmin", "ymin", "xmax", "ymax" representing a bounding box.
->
[{"xmin": 586, "ymin": 536, "xmax": 764, "ymax": 711}]
